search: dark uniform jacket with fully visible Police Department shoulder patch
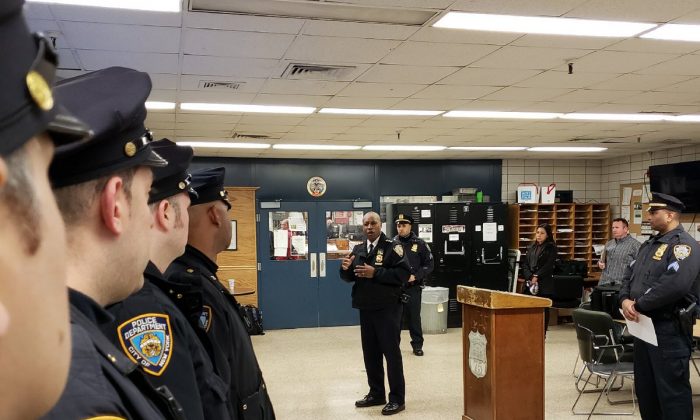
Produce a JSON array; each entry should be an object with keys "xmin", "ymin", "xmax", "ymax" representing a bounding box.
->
[{"xmin": 103, "ymin": 262, "xmax": 231, "ymax": 420}]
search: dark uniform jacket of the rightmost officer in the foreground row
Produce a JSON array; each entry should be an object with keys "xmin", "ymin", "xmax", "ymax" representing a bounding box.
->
[{"xmin": 166, "ymin": 245, "xmax": 275, "ymax": 419}]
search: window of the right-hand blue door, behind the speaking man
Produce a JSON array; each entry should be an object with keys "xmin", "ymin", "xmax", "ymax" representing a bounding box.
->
[{"xmin": 326, "ymin": 210, "xmax": 364, "ymax": 260}]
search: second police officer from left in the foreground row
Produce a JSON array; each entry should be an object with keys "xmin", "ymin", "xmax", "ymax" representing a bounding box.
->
[{"xmin": 47, "ymin": 67, "xmax": 183, "ymax": 420}]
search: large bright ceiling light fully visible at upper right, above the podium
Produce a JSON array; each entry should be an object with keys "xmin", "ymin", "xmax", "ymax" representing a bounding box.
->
[{"xmin": 433, "ymin": 12, "xmax": 657, "ymax": 38}]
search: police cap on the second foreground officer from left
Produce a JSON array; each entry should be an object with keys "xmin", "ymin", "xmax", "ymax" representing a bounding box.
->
[{"xmin": 49, "ymin": 67, "xmax": 168, "ymax": 188}]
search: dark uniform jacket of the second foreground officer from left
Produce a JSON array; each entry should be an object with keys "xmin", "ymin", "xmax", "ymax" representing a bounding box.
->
[{"xmin": 45, "ymin": 289, "xmax": 165, "ymax": 420}]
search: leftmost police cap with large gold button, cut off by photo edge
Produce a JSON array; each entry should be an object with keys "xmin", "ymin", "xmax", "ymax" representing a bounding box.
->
[{"xmin": 0, "ymin": 0, "xmax": 90, "ymax": 156}]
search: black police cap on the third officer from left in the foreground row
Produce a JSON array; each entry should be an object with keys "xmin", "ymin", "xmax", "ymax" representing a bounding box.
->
[{"xmin": 148, "ymin": 139, "xmax": 197, "ymax": 204}]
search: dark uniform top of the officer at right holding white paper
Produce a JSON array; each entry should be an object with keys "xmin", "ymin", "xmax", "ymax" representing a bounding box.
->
[{"xmin": 620, "ymin": 225, "xmax": 700, "ymax": 319}]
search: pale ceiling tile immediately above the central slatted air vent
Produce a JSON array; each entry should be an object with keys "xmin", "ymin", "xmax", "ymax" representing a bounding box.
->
[{"xmin": 285, "ymin": 36, "xmax": 399, "ymax": 64}]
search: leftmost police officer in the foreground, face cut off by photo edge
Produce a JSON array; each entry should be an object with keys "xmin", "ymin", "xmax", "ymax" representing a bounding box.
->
[{"xmin": 0, "ymin": 0, "xmax": 89, "ymax": 419}]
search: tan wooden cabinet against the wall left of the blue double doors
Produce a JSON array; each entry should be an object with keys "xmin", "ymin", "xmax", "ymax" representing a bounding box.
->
[{"xmin": 216, "ymin": 187, "xmax": 258, "ymax": 306}]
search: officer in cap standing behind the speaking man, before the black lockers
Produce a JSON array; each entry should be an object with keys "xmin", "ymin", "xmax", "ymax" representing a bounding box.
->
[{"xmin": 394, "ymin": 213, "xmax": 434, "ymax": 356}]
